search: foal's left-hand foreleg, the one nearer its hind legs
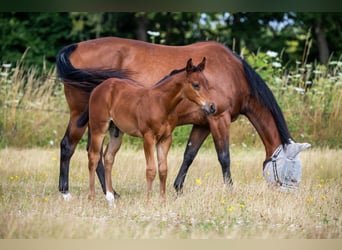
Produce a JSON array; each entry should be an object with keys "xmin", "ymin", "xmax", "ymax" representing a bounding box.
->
[{"xmin": 144, "ymin": 134, "xmax": 156, "ymax": 203}]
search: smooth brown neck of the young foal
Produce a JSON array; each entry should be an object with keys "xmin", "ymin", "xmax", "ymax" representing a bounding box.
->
[{"xmin": 150, "ymin": 72, "xmax": 185, "ymax": 113}]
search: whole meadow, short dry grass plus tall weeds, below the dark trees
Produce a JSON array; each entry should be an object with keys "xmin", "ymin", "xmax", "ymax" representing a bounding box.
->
[{"xmin": 0, "ymin": 48, "xmax": 342, "ymax": 239}]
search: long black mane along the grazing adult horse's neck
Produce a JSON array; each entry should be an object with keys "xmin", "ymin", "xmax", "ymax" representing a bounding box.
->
[{"xmin": 240, "ymin": 58, "xmax": 291, "ymax": 145}]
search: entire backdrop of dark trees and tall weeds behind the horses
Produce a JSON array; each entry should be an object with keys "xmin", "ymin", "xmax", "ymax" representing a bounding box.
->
[{"xmin": 0, "ymin": 12, "xmax": 342, "ymax": 148}]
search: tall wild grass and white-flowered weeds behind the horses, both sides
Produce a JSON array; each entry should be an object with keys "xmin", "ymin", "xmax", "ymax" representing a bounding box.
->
[{"xmin": 0, "ymin": 51, "xmax": 342, "ymax": 149}]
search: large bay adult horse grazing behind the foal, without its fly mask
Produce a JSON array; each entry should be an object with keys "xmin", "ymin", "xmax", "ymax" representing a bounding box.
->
[{"xmin": 57, "ymin": 37, "xmax": 291, "ymax": 197}]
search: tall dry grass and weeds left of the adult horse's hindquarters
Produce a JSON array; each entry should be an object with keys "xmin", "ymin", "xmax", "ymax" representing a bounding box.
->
[{"xmin": 0, "ymin": 57, "xmax": 68, "ymax": 148}]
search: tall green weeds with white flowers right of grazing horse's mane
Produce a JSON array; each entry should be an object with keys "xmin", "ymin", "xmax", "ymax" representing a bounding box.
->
[{"xmin": 243, "ymin": 48, "xmax": 342, "ymax": 147}]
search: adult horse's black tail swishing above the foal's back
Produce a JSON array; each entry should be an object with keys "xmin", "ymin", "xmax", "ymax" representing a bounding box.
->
[{"xmin": 56, "ymin": 44, "xmax": 132, "ymax": 93}]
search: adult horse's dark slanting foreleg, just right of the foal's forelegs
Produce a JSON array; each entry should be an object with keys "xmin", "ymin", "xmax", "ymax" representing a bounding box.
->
[{"xmin": 173, "ymin": 125, "xmax": 210, "ymax": 193}]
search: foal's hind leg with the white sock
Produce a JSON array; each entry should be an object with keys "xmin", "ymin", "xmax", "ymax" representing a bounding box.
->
[{"xmin": 104, "ymin": 124, "xmax": 123, "ymax": 205}]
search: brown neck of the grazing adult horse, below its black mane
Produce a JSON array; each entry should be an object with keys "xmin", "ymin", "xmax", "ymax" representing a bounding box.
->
[{"xmin": 245, "ymin": 97, "xmax": 282, "ymax": 159}]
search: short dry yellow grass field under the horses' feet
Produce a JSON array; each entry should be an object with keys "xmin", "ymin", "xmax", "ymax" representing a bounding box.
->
[{"xmin": 0, "ymin": 148, "xmax": 342, "ymax": 239}]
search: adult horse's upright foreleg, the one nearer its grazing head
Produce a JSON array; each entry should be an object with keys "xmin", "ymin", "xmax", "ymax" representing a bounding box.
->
[{"xmin": 208, "ymin": 112, "xmax": 233, "ymax": 185}]
